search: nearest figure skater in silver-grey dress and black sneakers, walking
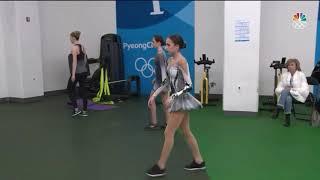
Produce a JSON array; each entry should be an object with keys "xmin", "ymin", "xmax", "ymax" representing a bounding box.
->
[{"xmin": 146, "ymin": 35, "xmax": 206, "ymax": 177}]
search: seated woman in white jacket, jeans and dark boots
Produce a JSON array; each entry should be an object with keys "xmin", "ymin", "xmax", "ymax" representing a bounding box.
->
[{"xmin": 273, "ymin": 59, "xmax": 309, "ymax": 127}]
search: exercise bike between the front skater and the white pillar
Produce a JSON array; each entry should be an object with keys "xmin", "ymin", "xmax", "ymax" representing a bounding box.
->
[{"xmin": 194, "ymin": 54, "xmax": 215, "ymax": 106}]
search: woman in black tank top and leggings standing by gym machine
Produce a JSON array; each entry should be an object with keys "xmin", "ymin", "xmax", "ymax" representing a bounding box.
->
[{"xmin": 67, "ymin": 31, "xmax": 88, "ymax": 116}]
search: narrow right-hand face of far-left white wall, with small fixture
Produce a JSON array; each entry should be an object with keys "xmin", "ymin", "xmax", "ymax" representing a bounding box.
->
[{"xmin": 15, "ymin": 1, "xmax": 43, "ymax": 98}]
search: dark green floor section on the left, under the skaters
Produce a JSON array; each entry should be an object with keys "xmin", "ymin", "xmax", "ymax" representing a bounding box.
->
[{"xmin": 0, "ymin": 96, "xmax": 209, "ymax": 180}]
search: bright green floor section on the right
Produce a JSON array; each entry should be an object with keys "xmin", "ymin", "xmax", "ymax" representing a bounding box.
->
[{"xmin": 192, "ymin": 100, "xmax": 320, "ymax": 180}]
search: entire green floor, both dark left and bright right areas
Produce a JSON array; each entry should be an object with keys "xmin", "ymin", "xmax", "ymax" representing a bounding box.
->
[{"xmin": 0, "ymin": 96, "xmax": 320, "ymax": 180}]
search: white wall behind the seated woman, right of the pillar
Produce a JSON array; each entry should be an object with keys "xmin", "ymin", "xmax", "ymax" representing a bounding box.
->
[{"xmin": 259, "ymin": 1, "xmax": 319, "ymax": 95}]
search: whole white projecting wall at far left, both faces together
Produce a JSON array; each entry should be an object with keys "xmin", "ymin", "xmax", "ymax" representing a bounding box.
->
[{"xmin": 0, "ymin": 1, "xmax": 43, "ymax": 98}]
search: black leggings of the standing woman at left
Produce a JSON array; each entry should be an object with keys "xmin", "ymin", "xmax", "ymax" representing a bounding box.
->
[{"xmin": 67, "ymin": 74, "xmax": 88, "ymax": 111}]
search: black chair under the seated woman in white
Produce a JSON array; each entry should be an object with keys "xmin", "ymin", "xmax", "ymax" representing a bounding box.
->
[{"xmin": 292, "ymin": 76, "xmax": 320, "ymax": 124}]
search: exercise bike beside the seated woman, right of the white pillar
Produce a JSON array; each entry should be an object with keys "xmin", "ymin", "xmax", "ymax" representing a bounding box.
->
[{"xmin": 260, "ymin": 57, "xmax": 286, "ymax": 111}]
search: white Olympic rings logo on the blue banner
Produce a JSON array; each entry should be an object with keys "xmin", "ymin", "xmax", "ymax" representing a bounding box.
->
[{"xmin": 134, "ymin": 57, "xmax": 155, "ymax": 78}]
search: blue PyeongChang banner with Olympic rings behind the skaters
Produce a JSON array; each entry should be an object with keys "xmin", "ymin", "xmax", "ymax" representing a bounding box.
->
[{"xmin": 116, "ymin": 0, "xmax": 194, "ymax": 95}]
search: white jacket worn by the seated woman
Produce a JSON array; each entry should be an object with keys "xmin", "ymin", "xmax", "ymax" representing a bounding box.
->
[{"xmin": 275, "ymin": 71, "xmax": 310, "ymax": 103}]
